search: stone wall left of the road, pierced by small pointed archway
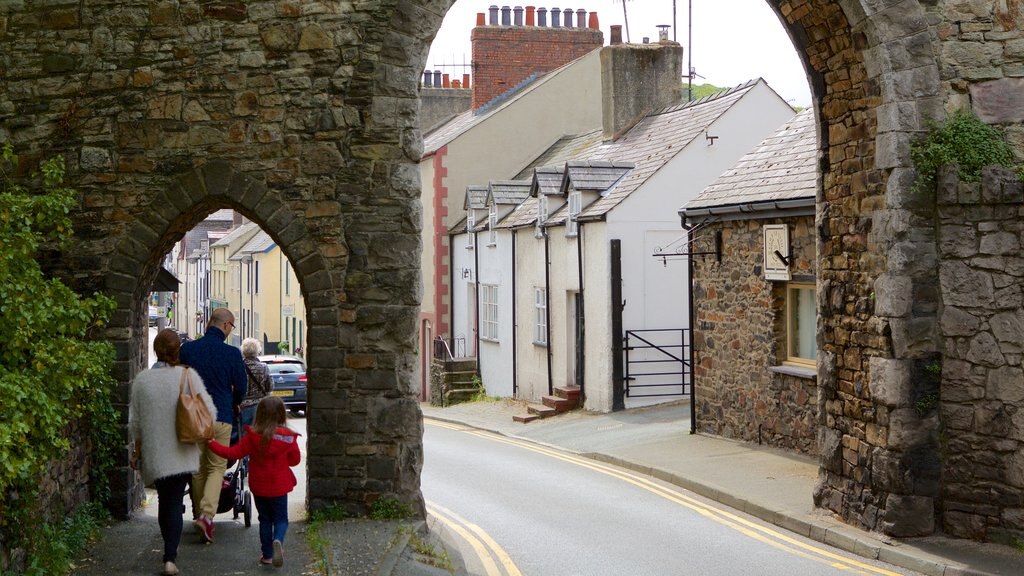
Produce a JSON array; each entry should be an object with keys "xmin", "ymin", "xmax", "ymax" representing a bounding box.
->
[{"xmin": 0, "ymin": 0, "xmax": 440, "ymax": 516}]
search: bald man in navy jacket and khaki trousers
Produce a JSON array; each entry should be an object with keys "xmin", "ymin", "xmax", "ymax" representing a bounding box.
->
[{"xmin": 181, "ymin": 308, "xmax": 247, "ymax": 542}]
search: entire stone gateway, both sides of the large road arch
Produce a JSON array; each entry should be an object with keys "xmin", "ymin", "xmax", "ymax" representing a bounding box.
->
[{"xmin": 0, "ymin": 0, "xmax": 1024, "ymax": 534}]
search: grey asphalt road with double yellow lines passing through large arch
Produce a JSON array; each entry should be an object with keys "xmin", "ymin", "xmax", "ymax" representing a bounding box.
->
[{"xmin": 415, "ymin": 420, "xmax": 915, "ymax": 576}]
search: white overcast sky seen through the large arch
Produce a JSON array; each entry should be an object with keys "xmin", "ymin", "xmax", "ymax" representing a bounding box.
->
[{"xmin": 426, "ymin": 0, "xmax": 811, "ymax": 107}]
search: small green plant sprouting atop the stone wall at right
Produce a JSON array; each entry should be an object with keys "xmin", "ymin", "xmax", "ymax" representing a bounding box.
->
[{"xmin": 910, "ymin": 110, "xmax": 1020, "ymax": 193}]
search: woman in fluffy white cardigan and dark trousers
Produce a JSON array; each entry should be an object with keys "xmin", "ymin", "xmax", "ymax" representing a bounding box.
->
[{"xmin": 128, "ymin": 329, "xmax": 217, "ymax": 576}]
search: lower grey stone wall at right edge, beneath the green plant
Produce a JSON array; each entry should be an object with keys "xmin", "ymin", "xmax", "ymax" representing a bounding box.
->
[{"xmin": 937, "ymin": 168, "xmax": 1024, "ymax": 541}]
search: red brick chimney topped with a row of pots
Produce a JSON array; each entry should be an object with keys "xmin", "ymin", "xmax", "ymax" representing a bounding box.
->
[{"xmin": 470, "ymin": 6, "xmax": 604, "ymax": 110}]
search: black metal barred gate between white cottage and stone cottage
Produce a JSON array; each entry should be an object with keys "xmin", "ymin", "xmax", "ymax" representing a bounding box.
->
[{"xmin": 624, "ymin": 328, "xmax": 693, "ymax": 398}]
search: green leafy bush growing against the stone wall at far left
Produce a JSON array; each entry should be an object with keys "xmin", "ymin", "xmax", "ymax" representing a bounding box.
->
[{"xmin": 0, "ymin": 145, "xmax": 120, "ymax": 573}]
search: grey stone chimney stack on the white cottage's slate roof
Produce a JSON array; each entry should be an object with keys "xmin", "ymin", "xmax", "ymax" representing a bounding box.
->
[{"xmin": 601, "ymin": 41, "xmax": 683, "ymax": 140}]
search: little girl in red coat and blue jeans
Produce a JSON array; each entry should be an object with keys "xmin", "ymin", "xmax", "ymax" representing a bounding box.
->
[{"xmin": 209, "ymin": 396, "xmax": 302, "ymax": 567}]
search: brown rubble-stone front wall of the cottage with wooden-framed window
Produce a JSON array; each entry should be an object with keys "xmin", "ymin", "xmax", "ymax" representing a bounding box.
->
[{"xmin": 694, "ymin": 216, "xmax": 817, "ymax": 454}]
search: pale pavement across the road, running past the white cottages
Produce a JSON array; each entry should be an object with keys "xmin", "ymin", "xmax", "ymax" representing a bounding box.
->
[{"xmin": 421, "ymin": 400, "xmax": 1024, "ymax": 576}]
